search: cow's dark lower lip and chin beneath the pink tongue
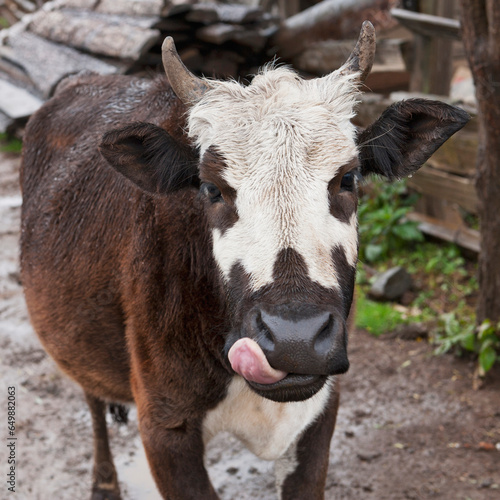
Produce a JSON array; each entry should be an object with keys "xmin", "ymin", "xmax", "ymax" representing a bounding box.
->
[{"xmin": 247, "ymin": 373, "xmax": 328, "ymax": 403}]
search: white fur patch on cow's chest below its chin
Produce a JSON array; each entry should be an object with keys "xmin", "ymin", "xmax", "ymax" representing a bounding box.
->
[{"xmin": 203, "ymin": 375, "xmax": 331, "ymax": 460}]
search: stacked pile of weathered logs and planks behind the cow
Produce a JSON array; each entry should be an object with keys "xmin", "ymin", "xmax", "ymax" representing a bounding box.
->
[{"xmin": 0, "ymin": 0, "xmax": 405, "ymax": 132}]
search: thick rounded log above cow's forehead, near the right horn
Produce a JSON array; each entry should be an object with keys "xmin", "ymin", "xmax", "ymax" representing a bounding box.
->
[{"xmin": 271, "ymin": 0, "xmax": 389, "ymax": 59}]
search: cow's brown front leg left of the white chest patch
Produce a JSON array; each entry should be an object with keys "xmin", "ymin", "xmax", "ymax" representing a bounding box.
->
[{"xmin": 140, "ymin": 410, "xmax": 218, "ymax": 500}]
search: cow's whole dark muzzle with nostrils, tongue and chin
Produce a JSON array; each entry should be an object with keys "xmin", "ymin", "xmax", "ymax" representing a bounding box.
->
[{"xmin": 228, "ymin": 305, "xmax": 349, "ymax": 401}]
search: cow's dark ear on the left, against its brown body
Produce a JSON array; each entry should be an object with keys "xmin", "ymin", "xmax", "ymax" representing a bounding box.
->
[{"xmin": 99, "ymin": 123, "xmax": 199, "ymax": 194}]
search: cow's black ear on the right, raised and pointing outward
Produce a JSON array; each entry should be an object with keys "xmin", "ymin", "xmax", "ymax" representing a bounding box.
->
[{"xmin": 358, "ymin": 99, "xmax": 470, "ymax": 180}]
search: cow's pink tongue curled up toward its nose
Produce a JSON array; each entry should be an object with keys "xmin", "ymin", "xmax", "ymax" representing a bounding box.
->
[{"xmin": 228, "ymin": 337, "xmax": 288, "ymax": 384}]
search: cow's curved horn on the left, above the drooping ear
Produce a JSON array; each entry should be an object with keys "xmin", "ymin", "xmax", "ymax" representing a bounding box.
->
[{"xmin": 161, "ymin": 36, "xmax": 209, "ymax": 104}]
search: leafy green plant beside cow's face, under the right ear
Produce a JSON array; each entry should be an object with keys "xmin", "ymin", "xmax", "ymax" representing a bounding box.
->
[{"xmin": 359, "ymin": 179, "xmax": 424, "ymax": 262}]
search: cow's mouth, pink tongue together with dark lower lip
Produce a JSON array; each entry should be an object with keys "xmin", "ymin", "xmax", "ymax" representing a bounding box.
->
[{"xmin": 228, "ymin": 338, "xmax": 327, "ymax": 403}]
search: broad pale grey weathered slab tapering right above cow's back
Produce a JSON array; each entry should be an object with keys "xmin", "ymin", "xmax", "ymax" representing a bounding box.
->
[{"xmin": 9, "ymin": 32, "xmax": 119, "ymax": 98}]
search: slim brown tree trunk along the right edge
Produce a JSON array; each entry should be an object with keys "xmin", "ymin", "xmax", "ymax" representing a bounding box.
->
[{"xmin": 461, "ymin": 0, "xmax": 500, "ymax": 323}]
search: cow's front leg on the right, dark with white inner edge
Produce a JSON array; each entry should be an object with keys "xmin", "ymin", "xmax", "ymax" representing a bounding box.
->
[{"xmin": 275, "ymin": 391, "xmax": 339, "ymax": 500}]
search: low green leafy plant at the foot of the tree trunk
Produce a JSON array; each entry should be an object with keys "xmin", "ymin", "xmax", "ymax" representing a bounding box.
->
[{"xmin": 434, "ymin": 313, "xmax": 500, "ymax": 376}]
